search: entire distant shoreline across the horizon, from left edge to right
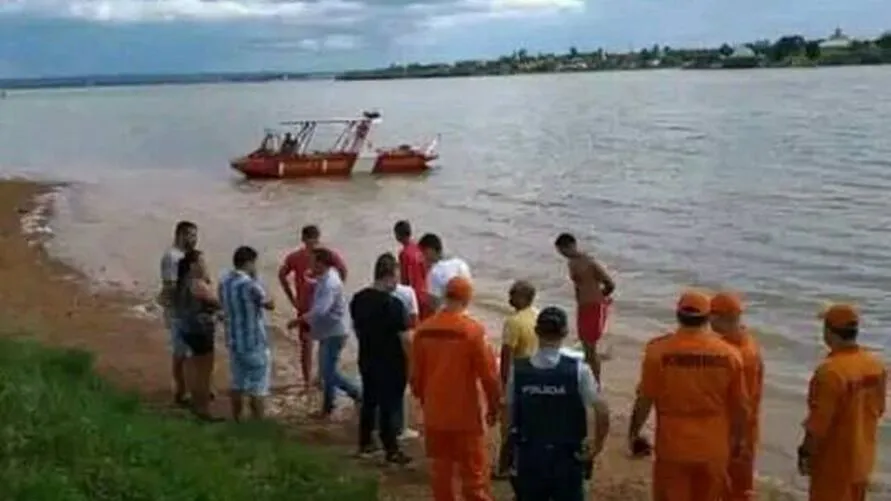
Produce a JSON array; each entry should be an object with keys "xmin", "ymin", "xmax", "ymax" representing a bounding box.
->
[{"xmin": 0, "ymin": 28, "xmax": 891, "ymax": 90}]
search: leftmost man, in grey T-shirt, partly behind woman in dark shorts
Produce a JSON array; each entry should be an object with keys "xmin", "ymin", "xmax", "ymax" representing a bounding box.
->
[{"xmin": 158, "ymin": 221, "xmax": 198, "ymax": 405}]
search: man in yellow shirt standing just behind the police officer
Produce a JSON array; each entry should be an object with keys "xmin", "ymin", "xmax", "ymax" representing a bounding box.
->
[{"xmin": 494, "ymin": 280, "xmax": 538, "ymax": 478}]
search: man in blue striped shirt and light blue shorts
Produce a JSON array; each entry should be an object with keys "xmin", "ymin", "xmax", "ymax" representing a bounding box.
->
[{"xmin": 219, "ymin": 247, "xmax": 274, "ymax": 421}]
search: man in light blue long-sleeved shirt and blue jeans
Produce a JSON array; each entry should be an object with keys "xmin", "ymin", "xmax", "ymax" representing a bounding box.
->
[{"xmin": 297, "ymin": 248, "xmax": 361, "ymax": 419}]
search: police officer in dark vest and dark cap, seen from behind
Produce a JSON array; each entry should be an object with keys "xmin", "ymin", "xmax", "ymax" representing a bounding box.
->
[{"xmin": 505, "ymin": 306, "xmax": 609, "ymax": 501}]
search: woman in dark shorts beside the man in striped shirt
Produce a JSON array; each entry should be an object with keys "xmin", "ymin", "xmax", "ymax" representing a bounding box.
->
[{"xmin": 174, "ymin": 249, "xmax": 220, "ymax": 421}]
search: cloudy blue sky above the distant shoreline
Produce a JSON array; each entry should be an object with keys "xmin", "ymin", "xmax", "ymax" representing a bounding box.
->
[{"xmin": 0, "ymin": 0, "xmax": 891, "ymax": 78}]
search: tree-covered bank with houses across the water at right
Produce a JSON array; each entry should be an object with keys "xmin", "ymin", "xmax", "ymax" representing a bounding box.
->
[{"xmin": 339, "ymin": 31, "xmax": 891, "ymax": 80}]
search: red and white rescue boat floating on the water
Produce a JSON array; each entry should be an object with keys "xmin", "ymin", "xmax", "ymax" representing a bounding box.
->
[{"xmin": 230, "ymin": 111, "xmax": 439, "ymax": 179}]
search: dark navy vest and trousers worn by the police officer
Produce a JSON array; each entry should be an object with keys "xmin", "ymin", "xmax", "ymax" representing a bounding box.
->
[{"xmin": 511, "ymin": 354, "xmax": 588, "ymax": 501}]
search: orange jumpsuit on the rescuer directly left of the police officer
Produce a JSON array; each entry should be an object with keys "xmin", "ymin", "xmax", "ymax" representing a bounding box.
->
[{"xmin": 410, "ymin": 310, "xmax": 501, "ymax": 501}]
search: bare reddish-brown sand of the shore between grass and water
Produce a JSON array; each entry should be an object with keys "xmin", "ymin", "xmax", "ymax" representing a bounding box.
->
[{"xmin": 0, "ymin": 181, "xmax": 804, "ymax": 501}]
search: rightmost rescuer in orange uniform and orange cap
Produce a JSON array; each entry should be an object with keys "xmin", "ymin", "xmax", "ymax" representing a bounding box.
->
[{"xmin": 798, "ymin": 304, "xmax": 888, "ymax": 501}]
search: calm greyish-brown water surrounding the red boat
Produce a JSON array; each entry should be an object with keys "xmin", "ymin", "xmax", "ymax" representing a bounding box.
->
[{"xmin": 0, "ymin": 68, "xmax": 891, "ymax": 488}]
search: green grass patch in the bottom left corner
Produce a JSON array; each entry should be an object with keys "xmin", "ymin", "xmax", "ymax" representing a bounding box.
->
[{"xmin": 0, "ymin": 333, "xmax": 378, "ymax": 501}]
